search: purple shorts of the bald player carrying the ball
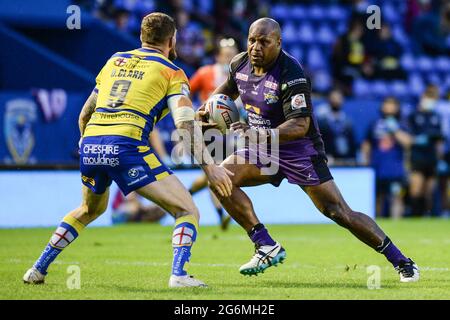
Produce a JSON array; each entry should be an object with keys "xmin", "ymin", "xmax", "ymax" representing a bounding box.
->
[{"xmin": 234, "ymin": 148, "xmax": 333, "ymax": 187}]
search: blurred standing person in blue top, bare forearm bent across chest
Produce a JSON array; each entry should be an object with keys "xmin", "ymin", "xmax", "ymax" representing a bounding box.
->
[{"xmin": 361, "ymin": 98, "xmax": 412, "ymax": 218}]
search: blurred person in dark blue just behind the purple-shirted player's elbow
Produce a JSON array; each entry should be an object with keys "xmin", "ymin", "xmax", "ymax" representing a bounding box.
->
[{"xmin": 318, "ymin": 89, "xmax": 356, "ymax": 165}]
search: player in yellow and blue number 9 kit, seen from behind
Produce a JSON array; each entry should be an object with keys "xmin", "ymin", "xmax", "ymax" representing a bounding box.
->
[{"xmin": 23, "ymin": 13, "xmax": 232, "ymax": 287}]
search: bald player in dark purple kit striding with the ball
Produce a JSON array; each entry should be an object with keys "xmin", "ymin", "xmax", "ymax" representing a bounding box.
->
[{"xmin": 201, "ymin": 18, "xmax": 419, "ymax": 282}]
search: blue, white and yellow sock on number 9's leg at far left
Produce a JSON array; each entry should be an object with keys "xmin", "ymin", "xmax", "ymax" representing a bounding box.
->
[{"xmin": 34, "ymin": 216, "xmax": 84, "ymax": 275}]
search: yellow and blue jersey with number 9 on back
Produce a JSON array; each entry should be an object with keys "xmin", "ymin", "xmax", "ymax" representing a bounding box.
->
[{"xmin": 83, "ymin": 48, "xmax": 189, "ymax": 144}]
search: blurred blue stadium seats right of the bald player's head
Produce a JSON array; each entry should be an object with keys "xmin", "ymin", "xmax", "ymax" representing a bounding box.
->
[{"xmin": 271, "ymin": 0, "xmax": 450, "ymax": 99}]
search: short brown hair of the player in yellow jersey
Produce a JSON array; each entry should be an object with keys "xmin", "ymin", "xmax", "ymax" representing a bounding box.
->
[{"xmin": 141, "ymin": 12, "xmax": 176, "ymax": 45}]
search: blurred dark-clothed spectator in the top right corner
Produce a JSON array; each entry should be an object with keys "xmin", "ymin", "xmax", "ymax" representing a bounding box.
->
[{"xmin": 412, "ymin": 1, "xmax": 450, "ymax": 56}]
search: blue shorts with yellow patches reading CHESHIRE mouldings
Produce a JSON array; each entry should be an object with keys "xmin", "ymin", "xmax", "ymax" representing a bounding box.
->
[{"xmin": 80, "ymin": 136, "xmax": 172, "ymax": 195}]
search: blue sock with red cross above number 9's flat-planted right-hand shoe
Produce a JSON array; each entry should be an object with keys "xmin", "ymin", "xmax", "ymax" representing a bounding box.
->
[{"xmin": 172, "ymin": 215, "xmax": 197, "ymax": 276}]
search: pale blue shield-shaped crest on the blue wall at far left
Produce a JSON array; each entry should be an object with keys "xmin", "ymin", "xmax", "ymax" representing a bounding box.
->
[{"xmin": 4, "ymin": 99, "xmax": 37, "ymax": 164}]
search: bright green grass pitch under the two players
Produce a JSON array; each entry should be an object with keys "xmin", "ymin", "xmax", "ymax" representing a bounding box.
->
[{"xmin": 0, "ymin": 219, "xmax": 450, "ymax": 300}]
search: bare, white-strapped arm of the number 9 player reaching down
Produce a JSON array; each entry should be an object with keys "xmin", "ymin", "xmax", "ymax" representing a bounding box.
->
[{"xmin": 168, "ymin": 95, "xmax": 233, "ymax": 197}]
